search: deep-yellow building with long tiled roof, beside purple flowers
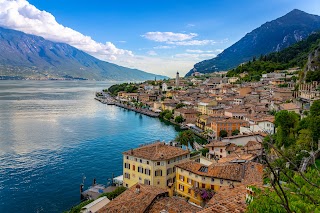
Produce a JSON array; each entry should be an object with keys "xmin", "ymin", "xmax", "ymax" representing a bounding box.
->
[{"xmin": 176, "ymin": 161, "xmax": 263, "ymax": 206}]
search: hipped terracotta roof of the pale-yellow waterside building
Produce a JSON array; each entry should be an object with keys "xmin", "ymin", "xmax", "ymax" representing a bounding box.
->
[{"xmin": 122, "ymin": 142, "xmax": 189, "ymax": 160}]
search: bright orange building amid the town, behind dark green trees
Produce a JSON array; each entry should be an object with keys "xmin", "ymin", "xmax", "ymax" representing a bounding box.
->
[{"xmin": 211, "ymin": 118, "xmax": 249, "ymax": 138}]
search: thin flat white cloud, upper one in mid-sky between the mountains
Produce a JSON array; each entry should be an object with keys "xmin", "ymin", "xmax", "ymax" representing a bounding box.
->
[{"xmin": 141, "ymin": 32, "xmax": 198, "ymax": 42}]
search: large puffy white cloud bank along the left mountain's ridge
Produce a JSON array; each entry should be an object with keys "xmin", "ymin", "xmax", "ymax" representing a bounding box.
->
[{"xmin": 0, "ymin": 0, "xmax": 133, "ymax": 60}]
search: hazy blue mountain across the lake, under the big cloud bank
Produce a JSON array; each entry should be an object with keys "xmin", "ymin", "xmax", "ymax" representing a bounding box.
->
[{"xmin": 0, "ymin": 27, "xmax": 166, "ymax": 81}]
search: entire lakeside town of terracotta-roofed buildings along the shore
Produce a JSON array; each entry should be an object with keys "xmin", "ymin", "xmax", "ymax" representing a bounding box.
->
[{"xmin": 75, "ymin": 68, "xmax": 320, "ymax": 213}]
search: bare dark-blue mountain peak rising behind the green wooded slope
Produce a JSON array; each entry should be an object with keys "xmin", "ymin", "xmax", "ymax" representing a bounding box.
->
[{"xmin": 187, "ymin": 9, "xmax": 320, "ymax": 76}]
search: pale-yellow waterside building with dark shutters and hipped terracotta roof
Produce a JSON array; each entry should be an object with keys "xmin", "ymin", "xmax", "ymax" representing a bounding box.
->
[{"xmin": 123, "ymin": 142, "xmax": 190, "ymax": 189}]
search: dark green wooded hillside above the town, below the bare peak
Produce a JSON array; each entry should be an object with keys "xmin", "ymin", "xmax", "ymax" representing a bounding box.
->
[{"xmin": 227, "ymin": 32, "xmax": 320, "ymax": 82}]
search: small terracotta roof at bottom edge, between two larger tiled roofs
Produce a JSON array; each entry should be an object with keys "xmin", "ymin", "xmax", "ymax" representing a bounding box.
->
[{"xmin": 148, "ymin": 197, "xmax": 201, "ymax": 213}]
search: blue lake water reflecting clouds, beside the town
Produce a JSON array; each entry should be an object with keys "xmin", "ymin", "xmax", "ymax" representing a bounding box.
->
[{"xmin": 0, "ymin": 81, "xmax": 177, "ymax": 213}]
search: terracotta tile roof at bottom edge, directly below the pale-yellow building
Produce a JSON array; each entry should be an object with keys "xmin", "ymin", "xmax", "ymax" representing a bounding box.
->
[{"xmin": 98, "ymin": 184, "xmax": 167, "ymax": 213}]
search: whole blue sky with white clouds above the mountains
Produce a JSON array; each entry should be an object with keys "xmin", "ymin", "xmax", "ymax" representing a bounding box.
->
[{"xmin": 0, "ymin": 0, "xmax": 320, "ymax": 77}]
